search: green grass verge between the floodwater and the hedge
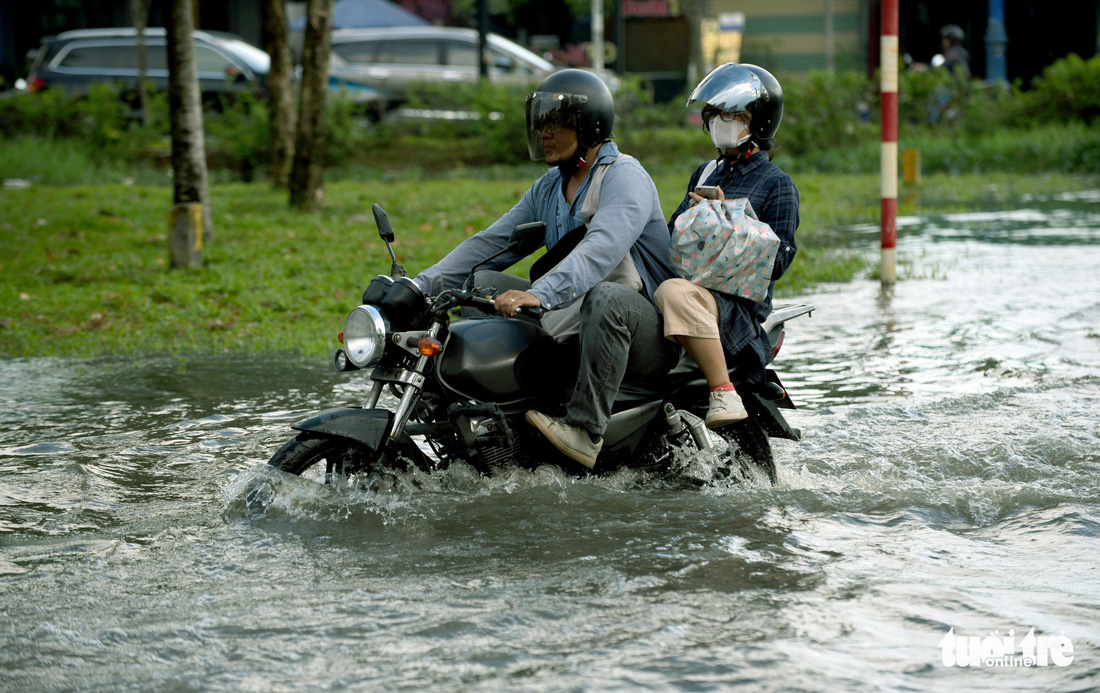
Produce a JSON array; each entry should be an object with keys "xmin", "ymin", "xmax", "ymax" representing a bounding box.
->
[{"xmin": 0, "ymin": 167, "xmax": 1097, "ymax": 358}]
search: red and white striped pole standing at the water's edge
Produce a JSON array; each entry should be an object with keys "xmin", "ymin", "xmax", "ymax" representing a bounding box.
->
[{"xmin": 879, "ymin": 0, "xmax": 898, "ymax": 284}]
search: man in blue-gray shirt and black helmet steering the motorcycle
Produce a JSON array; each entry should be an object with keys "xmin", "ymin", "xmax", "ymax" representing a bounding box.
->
[{"xmin": 415, "ymin": 69, "xmax": 680, "ymax": 469}]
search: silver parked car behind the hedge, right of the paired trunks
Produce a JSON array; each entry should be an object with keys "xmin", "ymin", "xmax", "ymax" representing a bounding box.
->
[{"xmin": 329, "ymin": 26, "xmax": 558, "ymax": 106}]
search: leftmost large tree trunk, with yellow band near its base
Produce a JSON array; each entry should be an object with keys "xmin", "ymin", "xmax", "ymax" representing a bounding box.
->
[{"xmin": 166, "ymin": 0, "xmax": 213, "ymax": 266}]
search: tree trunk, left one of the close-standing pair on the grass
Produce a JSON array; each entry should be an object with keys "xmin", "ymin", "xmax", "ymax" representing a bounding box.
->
[{"xmin": 263, "ymin": 0, "xmax": 294, "ymax": 188}]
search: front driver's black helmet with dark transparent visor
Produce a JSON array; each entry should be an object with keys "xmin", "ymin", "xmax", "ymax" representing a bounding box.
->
[{"xmin": 525, "ymin": 69, "xmax": 615, "ymax": 162}]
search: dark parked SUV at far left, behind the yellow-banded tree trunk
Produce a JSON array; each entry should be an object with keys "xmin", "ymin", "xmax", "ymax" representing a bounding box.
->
[{"xmin": 26, "ymin": 28, "xmax": 271, "ymax": 95}]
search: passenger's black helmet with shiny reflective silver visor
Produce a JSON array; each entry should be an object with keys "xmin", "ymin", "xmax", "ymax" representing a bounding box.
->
[{"xmin": 688, "ymin": 63, "xmax": 783, "ymax": 150}]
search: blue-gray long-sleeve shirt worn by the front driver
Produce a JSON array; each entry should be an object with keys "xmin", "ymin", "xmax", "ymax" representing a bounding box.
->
[{"xmin": 415, "ymin": 142, "xmax": 672, "ymax": 310}]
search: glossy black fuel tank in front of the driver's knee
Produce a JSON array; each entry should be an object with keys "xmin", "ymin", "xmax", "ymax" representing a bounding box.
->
[{"xmin": 438, "ymin": 318, "xmax": 578, "ymax": 405}]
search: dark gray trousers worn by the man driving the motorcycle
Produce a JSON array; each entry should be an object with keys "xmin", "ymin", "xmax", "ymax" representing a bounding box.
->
[{"xmin": 565, "ymin": 282, "xmax": 680, "ymax": 436}]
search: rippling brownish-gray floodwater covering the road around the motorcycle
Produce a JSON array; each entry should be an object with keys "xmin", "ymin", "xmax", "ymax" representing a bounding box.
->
[{"xmin": 0, "ymin": 194, "xmax": 1100, "ymax": 691}]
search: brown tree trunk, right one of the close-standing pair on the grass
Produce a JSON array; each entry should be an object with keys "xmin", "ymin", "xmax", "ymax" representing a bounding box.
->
[{"xmin": 289, "ymin": 0, "xmax": 332, "ymax": 209}]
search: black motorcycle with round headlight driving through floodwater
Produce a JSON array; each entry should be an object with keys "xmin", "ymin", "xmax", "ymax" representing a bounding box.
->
[{"xmin": 259, "ymin": 205, "xmax": 814, "ymax": 484}]
